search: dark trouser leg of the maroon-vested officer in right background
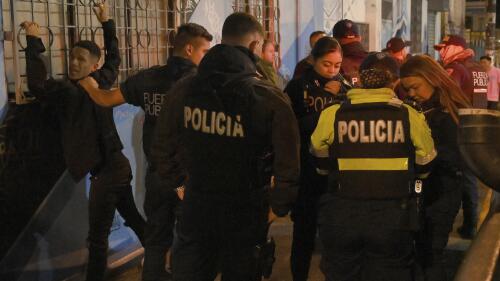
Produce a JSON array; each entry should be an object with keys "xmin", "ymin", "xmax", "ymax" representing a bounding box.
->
[{"xmin": 461, "ymin": 169, "xmax": 479, "ymax": 231}]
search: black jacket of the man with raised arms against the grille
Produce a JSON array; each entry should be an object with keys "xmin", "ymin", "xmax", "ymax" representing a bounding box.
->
[{"xmin": 25, "ymin": 20, "xmax": 123, "ymax": 181}]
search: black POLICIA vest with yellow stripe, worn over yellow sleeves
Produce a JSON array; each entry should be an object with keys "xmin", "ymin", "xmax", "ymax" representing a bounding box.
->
[{"xmin": 329, "ymin": 99, "xmax": 415, "ymax": 199}]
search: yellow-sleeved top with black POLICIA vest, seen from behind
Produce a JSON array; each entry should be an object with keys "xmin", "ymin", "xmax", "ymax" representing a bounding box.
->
[{"xmin": 311, "ymin": 89, "xmax": 436, "ymax": 199}]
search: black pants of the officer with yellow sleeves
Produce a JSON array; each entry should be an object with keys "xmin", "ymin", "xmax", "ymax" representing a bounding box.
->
[{"xmin": 319, "ymin": 193, "xmax": 415, "ymax": 281}]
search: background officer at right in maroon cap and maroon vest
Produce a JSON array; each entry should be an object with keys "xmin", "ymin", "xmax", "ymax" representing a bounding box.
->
[{"xmin": 434, "ymin": 35, "xmax": 488, "ymax": 239}]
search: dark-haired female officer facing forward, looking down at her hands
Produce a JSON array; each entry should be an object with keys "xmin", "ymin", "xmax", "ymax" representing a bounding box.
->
[{"xmin": 285, "ymin": 37, "xmax": 348, "ymax": 281}]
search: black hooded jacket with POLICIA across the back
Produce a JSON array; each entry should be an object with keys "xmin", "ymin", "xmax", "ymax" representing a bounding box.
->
[{"xmin": 152, "ymin": 45, "xmax": 299, "ymax": 216}]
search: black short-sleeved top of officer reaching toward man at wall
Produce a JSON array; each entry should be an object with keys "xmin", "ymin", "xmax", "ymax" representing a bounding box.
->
[{"xmin": 120, "ymin": 56, "xmax": 196, "ymax": 160}]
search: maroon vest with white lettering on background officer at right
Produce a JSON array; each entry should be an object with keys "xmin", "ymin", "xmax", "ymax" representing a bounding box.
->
[{"xmin": 463, "ymin": 60, "xmax": 488, "ymax": 108}]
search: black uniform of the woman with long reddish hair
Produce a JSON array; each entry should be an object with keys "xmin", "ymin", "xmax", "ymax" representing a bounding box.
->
[{"xmin": 417, "ymin": 95, "xmax": 465, "ymax": 281}]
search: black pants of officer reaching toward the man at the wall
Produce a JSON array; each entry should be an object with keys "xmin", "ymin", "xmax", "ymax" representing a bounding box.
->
[{"xmin": 142, "ymin": 170, "xmax": 180, "ymax": 281}]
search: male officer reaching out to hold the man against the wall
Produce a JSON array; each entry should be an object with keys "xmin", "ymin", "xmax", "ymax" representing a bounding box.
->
[{"xmin": 80, "ymin": 23, "xmax": 212, "ymax": 281}]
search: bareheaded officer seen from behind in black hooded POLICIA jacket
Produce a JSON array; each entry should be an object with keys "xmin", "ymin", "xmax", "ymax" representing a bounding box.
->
[{"xmin": 151, "ymin": 13, "xmax": 299, "ymax": 281}]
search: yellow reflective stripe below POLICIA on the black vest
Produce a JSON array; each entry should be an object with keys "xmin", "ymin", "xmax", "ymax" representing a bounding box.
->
[{"xmin": 338, "ymin": 158, "xmax": 408, "ymax": 171}]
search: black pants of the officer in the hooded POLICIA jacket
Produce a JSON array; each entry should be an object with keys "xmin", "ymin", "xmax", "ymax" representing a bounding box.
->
[{"xmin": 172, "ymin": 190, "xmax": 268, "ymax": 281}]
